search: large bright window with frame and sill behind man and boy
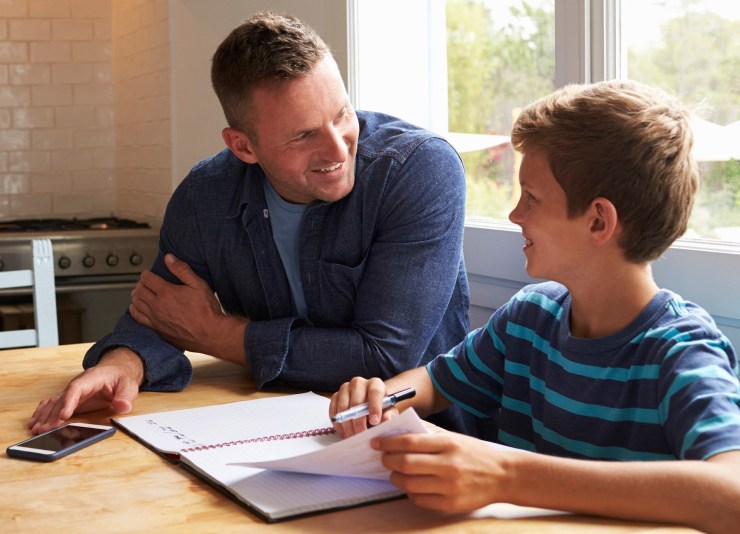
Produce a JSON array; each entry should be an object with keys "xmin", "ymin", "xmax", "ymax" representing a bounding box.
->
[{"xmin": 348, "ymin": 0, "xmax": 740, "ymax": 345}]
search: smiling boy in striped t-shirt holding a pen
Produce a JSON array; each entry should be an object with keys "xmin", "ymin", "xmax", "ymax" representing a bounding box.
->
[{"xmin": 330, "ymin": 81, "xmax": 740, "ymax": 532}]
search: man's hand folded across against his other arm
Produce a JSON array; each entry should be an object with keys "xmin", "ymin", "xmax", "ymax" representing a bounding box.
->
[{"xmin": 129, "ymin": 254, "xmax": 249, "ymax": 365}]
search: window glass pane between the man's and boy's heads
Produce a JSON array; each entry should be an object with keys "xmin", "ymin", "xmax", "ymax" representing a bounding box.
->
[{"xmin": 446, "ymin": 0, "xmax": 555, "ymax": 220}]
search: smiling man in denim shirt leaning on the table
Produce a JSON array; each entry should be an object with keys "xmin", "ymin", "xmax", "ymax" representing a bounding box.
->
[{"xmin": 29, "ymin": 13, "xmax": 469, "ymax": 433}]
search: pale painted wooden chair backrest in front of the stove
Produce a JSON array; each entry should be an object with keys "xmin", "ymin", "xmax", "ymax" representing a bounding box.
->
[{"xmin": 0, "ymin": 239, "xmax": 59, "ymax": 349}]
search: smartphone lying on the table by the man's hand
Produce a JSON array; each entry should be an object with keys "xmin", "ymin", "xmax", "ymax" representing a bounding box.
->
[{"xmin": 5, "ymin": 423, "xmax": 116, "ymax": 462}]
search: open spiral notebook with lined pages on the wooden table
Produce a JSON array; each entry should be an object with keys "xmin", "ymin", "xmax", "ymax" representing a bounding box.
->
[{"xmin": 111, "ymin": 393, "xmax": 427, "ymax": 522}]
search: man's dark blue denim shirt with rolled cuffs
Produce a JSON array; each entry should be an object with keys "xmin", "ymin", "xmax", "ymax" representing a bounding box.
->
[{"xmin": 83, "ymin": 112, "xmax": 469, "ymax": 391}]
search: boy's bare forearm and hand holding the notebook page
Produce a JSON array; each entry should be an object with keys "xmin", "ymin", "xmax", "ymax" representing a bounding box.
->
[{"xmin": 373, "ymin": 432, "xmax": 740, "ymax": 532}]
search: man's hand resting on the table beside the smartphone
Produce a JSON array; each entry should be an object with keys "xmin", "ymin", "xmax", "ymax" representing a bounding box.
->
[{"xmin": 28, "ymin": 348, "xmax": 144, "ymax": 434}]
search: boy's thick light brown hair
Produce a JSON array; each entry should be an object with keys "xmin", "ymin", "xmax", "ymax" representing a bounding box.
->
[{"xmin": 511, "ymin": 80, "xmax": 700, "ymax": 263}]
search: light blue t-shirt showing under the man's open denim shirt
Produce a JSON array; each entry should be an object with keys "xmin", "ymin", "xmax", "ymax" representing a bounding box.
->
[{"xmin": 262, "ymin": 179, "xmax": 308, "ymax": 320}]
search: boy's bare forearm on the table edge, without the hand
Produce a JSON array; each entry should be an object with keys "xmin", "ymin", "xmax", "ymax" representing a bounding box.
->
[{"xmin": 502, "ymin": 451, "xmax": 740, "ymax": 532}]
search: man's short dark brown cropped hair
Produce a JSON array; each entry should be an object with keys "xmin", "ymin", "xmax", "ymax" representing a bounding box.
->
[{"xmin": 211, "ymin": 11, "xmax": 330, "ymax": 142}]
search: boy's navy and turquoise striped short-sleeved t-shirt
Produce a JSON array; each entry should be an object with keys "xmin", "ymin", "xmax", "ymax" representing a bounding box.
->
[{"xmin": 428, "ymin": 282, "xmax": 740, "ymax": 460}]
